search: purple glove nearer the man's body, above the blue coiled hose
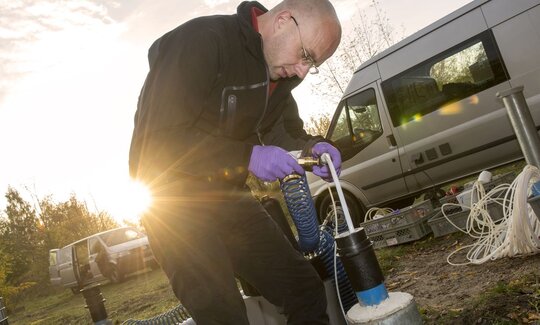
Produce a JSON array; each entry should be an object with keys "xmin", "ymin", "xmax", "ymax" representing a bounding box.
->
[{"xmin": 248, "ymin": 146, "xmax": 304, "ymax": 182}]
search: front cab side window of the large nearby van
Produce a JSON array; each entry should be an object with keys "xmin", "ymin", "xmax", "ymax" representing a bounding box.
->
[{"xmin": 329, "ymin": 88, "xmax": 382, "ymax": 159}]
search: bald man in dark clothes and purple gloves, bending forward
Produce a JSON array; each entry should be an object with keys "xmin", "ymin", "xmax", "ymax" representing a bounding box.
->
[{"xmin": 130, "ymin": 0, "xmax": 341, "ymax": 325}]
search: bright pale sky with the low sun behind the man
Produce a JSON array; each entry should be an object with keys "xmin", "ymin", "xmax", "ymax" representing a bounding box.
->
[{"xmin": 0, "ymin": 0, "xmax": 470, "ymax": 222}]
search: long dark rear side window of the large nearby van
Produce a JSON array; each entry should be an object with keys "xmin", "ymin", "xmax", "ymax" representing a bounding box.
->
[{"xmin": 382, "ymin": 30, "xmax": 508, "ymax": 126}]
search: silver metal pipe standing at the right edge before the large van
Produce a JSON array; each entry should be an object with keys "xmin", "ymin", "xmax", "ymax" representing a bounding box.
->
[{"xmin": 496, "ymin": 86, "xmax": 540, "ymax": 168}]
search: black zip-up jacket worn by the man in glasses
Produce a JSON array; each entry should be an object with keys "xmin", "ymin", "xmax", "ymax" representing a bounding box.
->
[{"xmin": 129, "ymin": 2, "xmax": 313, "ymax": 185}]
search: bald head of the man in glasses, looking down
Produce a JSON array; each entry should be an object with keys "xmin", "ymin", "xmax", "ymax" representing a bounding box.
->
[{"xmin": 258, "ymin": 0, "xmax": 341, "ymax": 78}]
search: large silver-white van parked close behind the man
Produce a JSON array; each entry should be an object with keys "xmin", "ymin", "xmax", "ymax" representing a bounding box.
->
[{"xmin": 309, "ymin": 0, "xmax": 540, "ymax": 224}]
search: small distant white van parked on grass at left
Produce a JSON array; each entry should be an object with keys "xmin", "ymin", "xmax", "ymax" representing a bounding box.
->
[{"xmin": 49, "ymin": 227, "xmax": 158, "ymax": 293}]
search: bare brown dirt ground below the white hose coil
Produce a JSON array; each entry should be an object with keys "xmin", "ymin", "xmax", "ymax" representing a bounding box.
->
[{"xmin": 385, "ymin": 233, "xmax": 540, "ymax": 324}]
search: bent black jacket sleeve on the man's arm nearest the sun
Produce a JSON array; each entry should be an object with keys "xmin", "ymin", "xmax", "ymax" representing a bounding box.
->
[{"xmin": 130, "ymin": 21, "xmax": 252, "ymax": 184}]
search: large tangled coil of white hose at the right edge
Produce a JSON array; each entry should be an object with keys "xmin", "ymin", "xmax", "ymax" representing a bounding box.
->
[{"xmin": 441, "ymin": 165, "xmax": 540, "ymax": 265}]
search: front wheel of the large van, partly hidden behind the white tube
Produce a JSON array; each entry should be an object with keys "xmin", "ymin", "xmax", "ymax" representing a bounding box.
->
[{"xmin": 319, "ymin": 191, "xmax": 364, "ymax": 230}]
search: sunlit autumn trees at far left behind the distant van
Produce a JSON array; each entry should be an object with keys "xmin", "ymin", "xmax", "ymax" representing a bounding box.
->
[{"xmin": 0, "ymin": 187, "xmax": 118, "ymax": 296}]
